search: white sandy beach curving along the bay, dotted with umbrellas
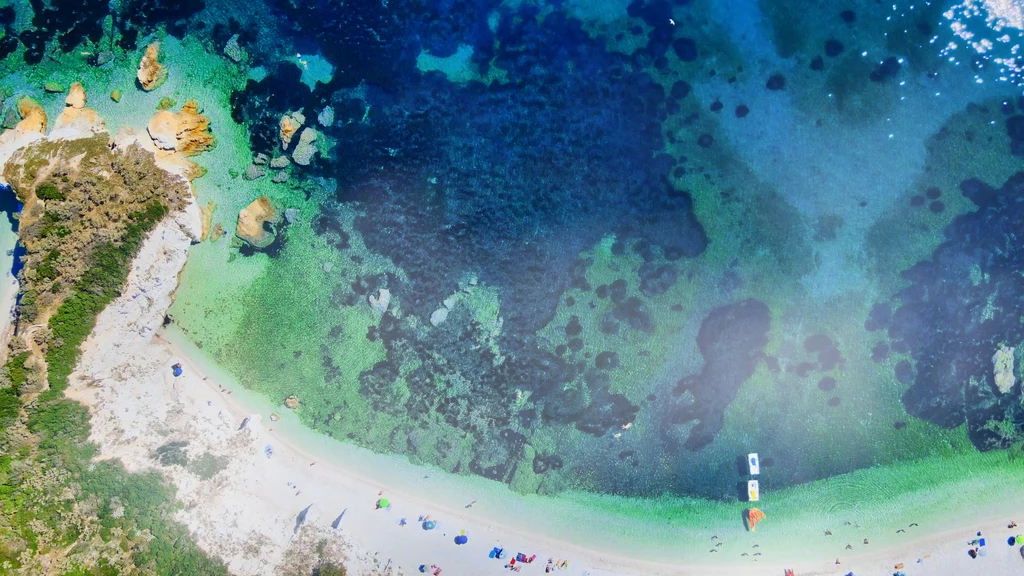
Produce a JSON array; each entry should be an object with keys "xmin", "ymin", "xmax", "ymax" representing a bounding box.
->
[{"xmin": 61, "ymin": 198, "xmax": 1024, "ymax": 576}]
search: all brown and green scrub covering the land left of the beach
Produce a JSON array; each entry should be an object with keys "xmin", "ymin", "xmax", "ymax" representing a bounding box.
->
[{"xmin": 0, "ymin": 136, "xmax": 226, "ymax": 576}]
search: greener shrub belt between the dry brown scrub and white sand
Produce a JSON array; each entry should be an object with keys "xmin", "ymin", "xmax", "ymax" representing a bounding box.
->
[{"xmin": 0, "ymin": 194, "xmax": 227, "ymax": 576}]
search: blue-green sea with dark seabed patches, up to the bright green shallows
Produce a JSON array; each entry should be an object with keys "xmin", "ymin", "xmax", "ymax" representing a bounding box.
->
[{"xmin": 0, "ymin": 0, "xmax": 1024, "ymax": 506}]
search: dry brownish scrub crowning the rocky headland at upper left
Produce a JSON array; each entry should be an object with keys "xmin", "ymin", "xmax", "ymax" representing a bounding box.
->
[{"xmin": 4, "ymin": 135, "xmax": 189, "ymax": 323}]
